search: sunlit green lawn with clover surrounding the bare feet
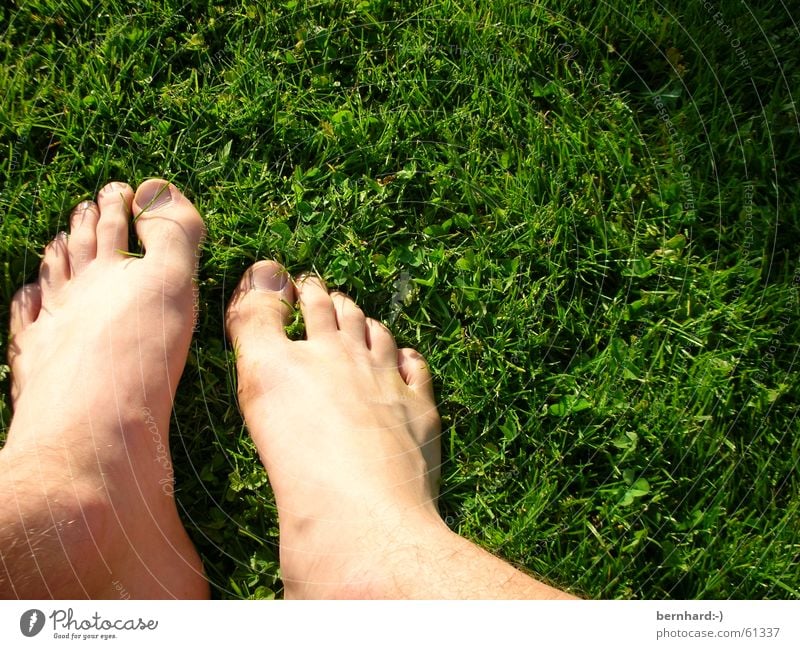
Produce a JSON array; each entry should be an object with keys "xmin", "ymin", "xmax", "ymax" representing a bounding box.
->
[{"xmin": 0, "ymin": 0, "xmax": 800, "ymax": 598}]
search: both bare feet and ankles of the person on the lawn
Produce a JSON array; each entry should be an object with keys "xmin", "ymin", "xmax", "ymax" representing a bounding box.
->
[{"xmin": 0, "ymin": 179, "xmax": 569, "ymax": 599}]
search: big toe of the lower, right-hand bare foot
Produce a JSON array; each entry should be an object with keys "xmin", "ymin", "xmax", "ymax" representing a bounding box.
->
[{"xmin": 225, "ymin": 261, "xmax": 295, "ymax": 347}]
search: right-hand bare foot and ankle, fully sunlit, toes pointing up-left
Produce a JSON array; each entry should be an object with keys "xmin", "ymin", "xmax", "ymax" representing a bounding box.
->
[{"xmin": 228, "ymin": 262, "xmax": 568, "ymax": 598}]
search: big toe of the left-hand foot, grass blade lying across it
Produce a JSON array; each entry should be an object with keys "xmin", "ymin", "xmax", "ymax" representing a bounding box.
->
[{"xmin": 133, "ymin": 178, "xmax": 205, "ymax": 272}]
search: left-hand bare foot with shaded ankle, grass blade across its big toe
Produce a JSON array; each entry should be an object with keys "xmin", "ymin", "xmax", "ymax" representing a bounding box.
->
[{"xmin": 0, "ymin": 180, "xmax": 208, "ymax": 598}]
